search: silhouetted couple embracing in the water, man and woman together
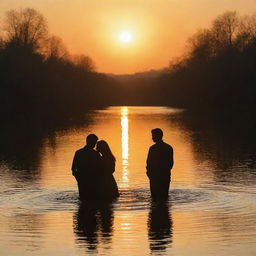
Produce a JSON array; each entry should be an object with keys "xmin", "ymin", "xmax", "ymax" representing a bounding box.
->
[{"xmin": 72, "ymin": 134, "xmax": 119, "ymax": 201}]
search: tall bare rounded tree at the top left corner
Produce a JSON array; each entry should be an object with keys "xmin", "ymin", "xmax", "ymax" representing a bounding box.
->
[{"xmin": 4, "ymin": 8, "xmax": 47, "ymax": 50}]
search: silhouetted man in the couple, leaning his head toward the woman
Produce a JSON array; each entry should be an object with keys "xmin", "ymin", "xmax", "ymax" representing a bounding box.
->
[{"xmin": 72, "ymin": 134, "xmax": 101, "ymax": 200}]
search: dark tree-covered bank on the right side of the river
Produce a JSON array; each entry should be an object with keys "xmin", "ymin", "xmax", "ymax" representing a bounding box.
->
[{"xmin": 151, "ymin": 11, "xmax": 256, "ymax": 111}]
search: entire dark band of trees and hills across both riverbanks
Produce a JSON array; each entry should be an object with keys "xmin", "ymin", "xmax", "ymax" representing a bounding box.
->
[{"xmin": 0, "ymin": 8, "xmax": 256, "ymax": 126}]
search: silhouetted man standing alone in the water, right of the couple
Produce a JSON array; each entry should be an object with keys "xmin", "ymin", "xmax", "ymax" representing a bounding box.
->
[{"xmin": 147, "ymin": 128, "xmax": 173, "ymax": 200}]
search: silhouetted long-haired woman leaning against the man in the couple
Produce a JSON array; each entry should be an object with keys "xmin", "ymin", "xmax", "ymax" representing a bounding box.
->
[{"xmin": 97, "ymin": 140, "xmax": 119, "ymax": 199}]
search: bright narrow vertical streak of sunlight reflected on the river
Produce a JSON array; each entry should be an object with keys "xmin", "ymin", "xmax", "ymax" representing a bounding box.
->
[{"xmin": 120, "ymin": 107, "xmax": 129, "ymax": 188}]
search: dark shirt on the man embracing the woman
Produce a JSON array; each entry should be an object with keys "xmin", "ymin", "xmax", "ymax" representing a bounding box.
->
[{"xmin": 72, "ymin": 146, "xmax": 100, "ymax": 179}]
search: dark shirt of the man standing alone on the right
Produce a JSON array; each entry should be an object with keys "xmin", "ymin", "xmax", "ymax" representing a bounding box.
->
[{"xmin": 147, "ymin": 141, "xmax": 173, "ymax": 178}]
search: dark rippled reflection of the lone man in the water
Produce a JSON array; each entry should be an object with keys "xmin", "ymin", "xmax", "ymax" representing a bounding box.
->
[{"xmin": 148, "ymin": 202, "xmax": 172, "ymax": 252}]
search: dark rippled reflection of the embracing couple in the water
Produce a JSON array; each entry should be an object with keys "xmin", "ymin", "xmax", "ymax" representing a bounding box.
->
[{"xmin": 74, "ymin": 203, "xmax": 114, "ymax": 251}]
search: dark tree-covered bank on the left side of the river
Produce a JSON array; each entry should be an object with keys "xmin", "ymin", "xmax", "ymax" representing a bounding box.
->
[{"xmin": 0, "ymin": 8, "xmax": 116, "ymax": 124}]
